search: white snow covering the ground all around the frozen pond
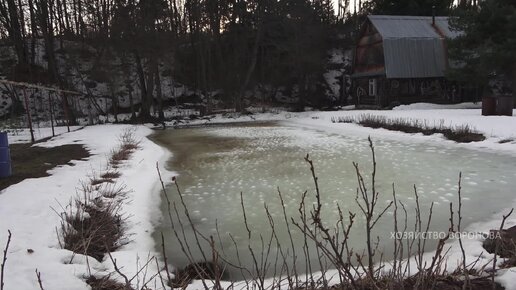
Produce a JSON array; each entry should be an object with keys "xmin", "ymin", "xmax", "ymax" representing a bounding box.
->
[{"xmin": 0, "ymin": 104, "xmax": 516, "ymax": 290}]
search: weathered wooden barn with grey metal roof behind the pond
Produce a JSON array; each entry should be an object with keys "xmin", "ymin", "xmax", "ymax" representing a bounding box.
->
[{"xmin": 351, "ymin": 15, "xmax": 474, "ymax": 107}]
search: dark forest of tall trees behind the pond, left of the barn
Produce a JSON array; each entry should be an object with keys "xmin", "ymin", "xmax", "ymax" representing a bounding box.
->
[{"xmin": 0, "ymin": 0, "xmax": 514, "ymax": 120}]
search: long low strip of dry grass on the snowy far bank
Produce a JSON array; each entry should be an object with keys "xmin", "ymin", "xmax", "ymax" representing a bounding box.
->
[{"xmin": 332, "ymin": 114, "xmax": 486, "ymax": 143}]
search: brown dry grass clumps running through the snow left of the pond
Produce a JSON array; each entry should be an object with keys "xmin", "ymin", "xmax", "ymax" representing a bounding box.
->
[{"xmin": 59, "ymin": 130, "xmax": 138, "ymax": 262}]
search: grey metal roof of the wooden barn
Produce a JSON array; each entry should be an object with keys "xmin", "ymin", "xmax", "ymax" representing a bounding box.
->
[{"xmin": 368, "ymin": 15, "xmax": 460, "ymax": 78}]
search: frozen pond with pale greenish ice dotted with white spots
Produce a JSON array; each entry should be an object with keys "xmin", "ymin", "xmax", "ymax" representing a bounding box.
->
[{"xmin": 154, "ymin": 123, "xmax": 516, "ymax": 279}]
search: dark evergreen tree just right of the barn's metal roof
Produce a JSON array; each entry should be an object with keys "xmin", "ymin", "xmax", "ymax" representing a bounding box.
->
[{"xmin": 449, "ymin": 0, "xmax": 516, "ymax": 102}]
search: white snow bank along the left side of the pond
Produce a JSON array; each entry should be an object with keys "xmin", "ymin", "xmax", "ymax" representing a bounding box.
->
[{"xmin": 0, "ymin": 125, "xmax": 170, "ymax": 290}]
